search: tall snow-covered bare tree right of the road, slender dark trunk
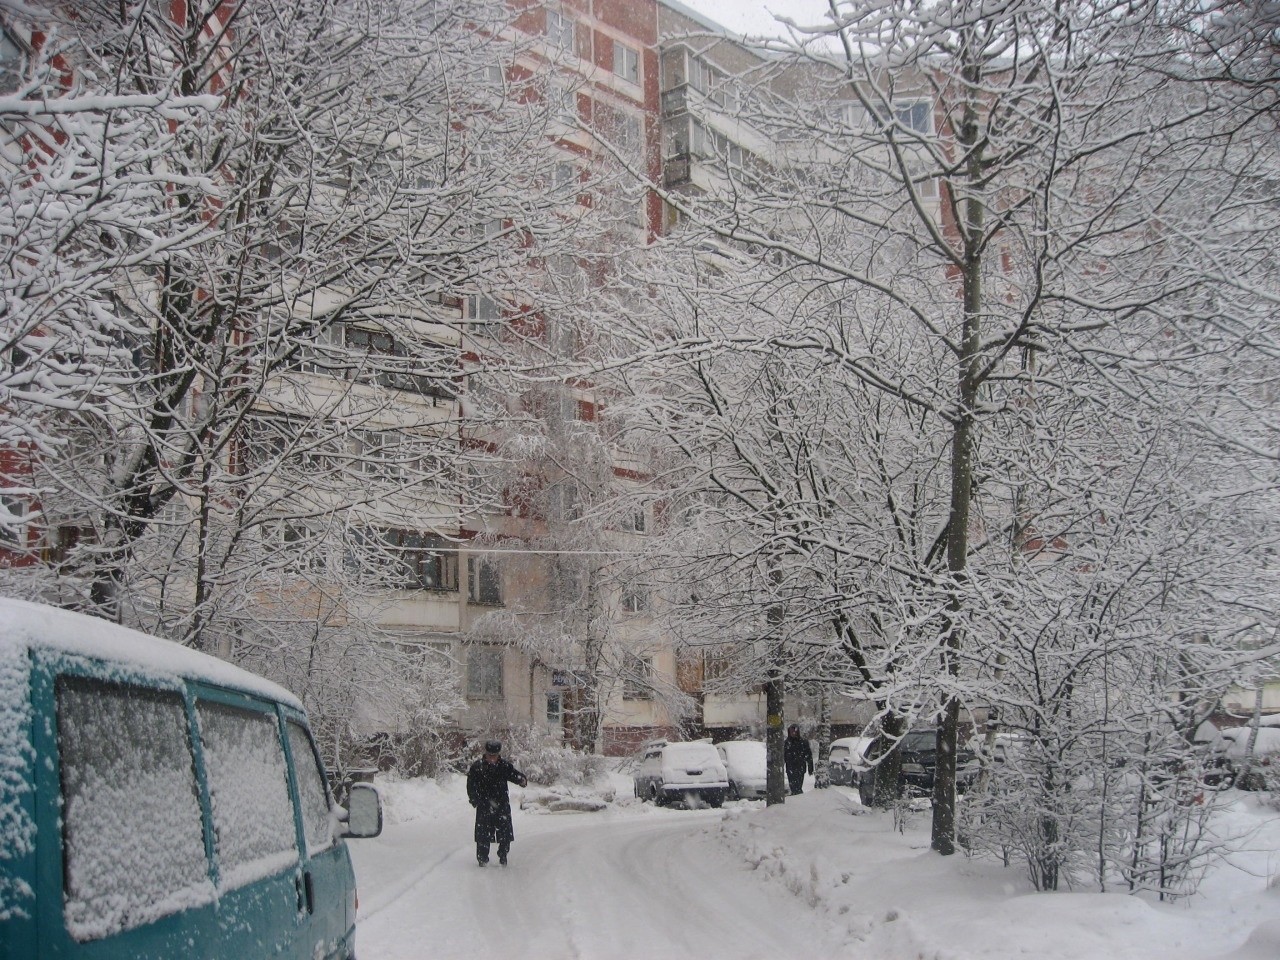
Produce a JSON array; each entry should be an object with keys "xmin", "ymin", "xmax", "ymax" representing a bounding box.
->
[{"xmin": 604, "ymin": 3, "xmax": 1276, "ymax": 870}]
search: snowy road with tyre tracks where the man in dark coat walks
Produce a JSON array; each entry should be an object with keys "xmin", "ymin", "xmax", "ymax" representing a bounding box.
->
[{"xmin": 351, "ymin": 805, "xmax": 847, "ymax": 960}]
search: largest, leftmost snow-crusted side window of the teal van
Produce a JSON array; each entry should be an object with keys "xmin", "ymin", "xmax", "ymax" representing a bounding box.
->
[{"xmin": 56, "ymin": 676, "xmax": 214, "ymax": 941}]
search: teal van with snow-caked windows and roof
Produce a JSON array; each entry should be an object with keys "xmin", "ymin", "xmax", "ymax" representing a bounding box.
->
[{"xmin": 0, "ymin": 598, "xmax": 381, "ymax": 960}]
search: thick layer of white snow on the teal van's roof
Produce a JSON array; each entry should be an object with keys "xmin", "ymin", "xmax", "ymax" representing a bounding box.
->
[{"xmin": 0, "ymin": 596, "xmax": 302, "ymax": 710}]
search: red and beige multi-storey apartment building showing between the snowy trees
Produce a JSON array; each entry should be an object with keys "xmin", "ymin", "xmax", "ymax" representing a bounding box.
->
[{"xmin": 0, "ymin": 0, "xmax": 929, "ymax": 754}]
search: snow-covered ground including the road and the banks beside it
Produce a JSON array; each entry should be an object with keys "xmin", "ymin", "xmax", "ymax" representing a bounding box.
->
[{"xmin": 349, "ymin": 774, "xmax": 1280, "ymax": 960}]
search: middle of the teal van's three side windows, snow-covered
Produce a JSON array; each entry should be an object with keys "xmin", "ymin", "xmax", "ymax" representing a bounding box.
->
[{"xmin": 196, "ymin": 700, "xmax": 298, "ymax": 890}]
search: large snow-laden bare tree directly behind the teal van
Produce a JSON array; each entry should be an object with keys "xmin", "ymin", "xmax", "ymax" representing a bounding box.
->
[{"xmin": 5, "ymin": 0, "xmax": 609, "ymax": 762}]
